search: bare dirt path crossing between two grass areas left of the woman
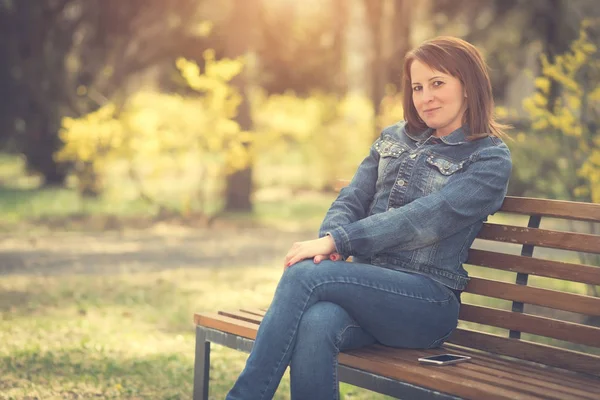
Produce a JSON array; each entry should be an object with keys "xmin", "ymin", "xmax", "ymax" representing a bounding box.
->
[{"xmin": 0, "ymin": 224, "xmax": 316, "ymax": 275}]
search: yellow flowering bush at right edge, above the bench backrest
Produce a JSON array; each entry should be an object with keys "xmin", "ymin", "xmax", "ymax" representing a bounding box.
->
[{"xmin": 523, "ymin": 21, "xmax": 600, "ymax": 203}]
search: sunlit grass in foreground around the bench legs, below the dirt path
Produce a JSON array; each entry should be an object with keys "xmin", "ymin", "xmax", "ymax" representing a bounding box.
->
[{"xmin": 0, "ymin": 267, "xmax": 394, "ymax": 399}]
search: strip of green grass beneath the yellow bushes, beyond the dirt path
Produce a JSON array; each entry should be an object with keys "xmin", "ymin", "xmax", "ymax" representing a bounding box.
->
[{"xmin": 0, "ymin": 153, "xmax": 335, "ymax": 232}]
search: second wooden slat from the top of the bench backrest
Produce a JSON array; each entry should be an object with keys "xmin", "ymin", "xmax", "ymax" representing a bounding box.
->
[{"xmin": 477, "ymin": 223, "xmax": 600, "ymax": 254}]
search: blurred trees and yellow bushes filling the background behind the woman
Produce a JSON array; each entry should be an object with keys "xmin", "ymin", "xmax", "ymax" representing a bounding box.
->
[{"xmin": 0, "ymin": 0, "xmax": 600, "ymax": 225}]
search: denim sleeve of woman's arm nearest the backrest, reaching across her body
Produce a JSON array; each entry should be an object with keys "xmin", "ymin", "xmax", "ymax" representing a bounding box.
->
[{"xmin": 329, "ymin": 145, "xmax": 512, "ymax": 258}]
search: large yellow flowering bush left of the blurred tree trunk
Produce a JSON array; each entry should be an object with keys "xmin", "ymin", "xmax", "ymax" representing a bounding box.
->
[{"xmin": 56, "ymin": 50, "xmax": 252, "ymax": 212}]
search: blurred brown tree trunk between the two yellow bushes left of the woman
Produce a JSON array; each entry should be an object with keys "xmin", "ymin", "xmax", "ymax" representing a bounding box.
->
[{"xmin": 224, "ymin": 0, "xmax": 259, "ymax": 211}]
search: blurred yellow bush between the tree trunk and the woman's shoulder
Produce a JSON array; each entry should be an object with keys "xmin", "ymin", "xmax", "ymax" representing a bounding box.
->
[{"xmin": 253, "ymin": 93, "xmax": 374, "ymax": 189}]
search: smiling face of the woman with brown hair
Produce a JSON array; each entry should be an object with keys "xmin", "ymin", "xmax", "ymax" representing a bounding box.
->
[{"xmin": 410, "ymin": 60, "xmax": 467, "ymax": 136}]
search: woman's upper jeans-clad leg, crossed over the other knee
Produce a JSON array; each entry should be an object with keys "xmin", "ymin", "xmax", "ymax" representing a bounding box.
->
[{"xmin": 227, "ymin": 260, "xmax": 459, "ymax": 400}]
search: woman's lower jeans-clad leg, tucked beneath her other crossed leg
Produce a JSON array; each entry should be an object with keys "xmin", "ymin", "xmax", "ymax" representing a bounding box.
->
[{"xmin": 290, "ymin": 301, "xmax": 375, "ymax": 400}]
